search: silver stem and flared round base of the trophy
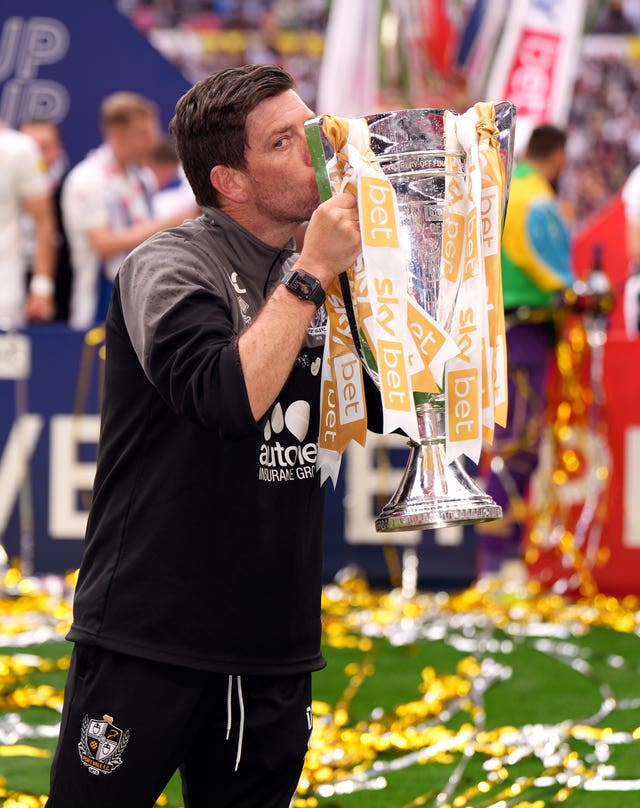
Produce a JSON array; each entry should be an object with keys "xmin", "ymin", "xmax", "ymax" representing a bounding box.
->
[{"xmin": 376, "ymin": 396, "xmax": 502, "ymax": 533}]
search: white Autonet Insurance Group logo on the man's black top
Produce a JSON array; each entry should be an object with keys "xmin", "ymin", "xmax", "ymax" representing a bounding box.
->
[{"xmin": 258, "ymin": 401, "xmax": 318, "ymax": 483}]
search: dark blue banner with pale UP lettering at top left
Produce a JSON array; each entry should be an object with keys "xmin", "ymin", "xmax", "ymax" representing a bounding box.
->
[{"xmin": 0, "ymin": 0, "xmax": 189, "ymax": 165}]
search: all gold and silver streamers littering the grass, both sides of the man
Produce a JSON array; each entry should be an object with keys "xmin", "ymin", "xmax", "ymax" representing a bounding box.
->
[{"xmin": 0, "ymin": 570, "xmax": 640, "ymax": 808}]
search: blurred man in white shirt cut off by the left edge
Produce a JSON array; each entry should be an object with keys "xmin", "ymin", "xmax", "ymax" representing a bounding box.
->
[{"xmin": 0, "ymin": 124, "xmax": 55, "ymax": 331}]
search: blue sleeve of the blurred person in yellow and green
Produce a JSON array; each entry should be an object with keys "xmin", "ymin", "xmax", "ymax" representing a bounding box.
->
[{"xmin": 523, "ymin": 199, "xmax": 573, "ymax": 292}]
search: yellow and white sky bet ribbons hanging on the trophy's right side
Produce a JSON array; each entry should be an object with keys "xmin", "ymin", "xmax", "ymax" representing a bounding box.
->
[{"xmin": 439, "ymin": 104, "xmax": 507, "ymax": 463}]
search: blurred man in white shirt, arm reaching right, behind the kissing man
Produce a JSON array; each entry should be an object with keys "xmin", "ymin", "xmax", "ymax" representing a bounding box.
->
[{"xmin": 62, "ymin": 92, "xmax": 195, "ymax": 329}]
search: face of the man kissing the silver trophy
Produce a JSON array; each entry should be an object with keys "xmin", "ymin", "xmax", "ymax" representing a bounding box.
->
[{"xmin": 243, "ymin": 90, "xmax": 320, "ymax": 224}]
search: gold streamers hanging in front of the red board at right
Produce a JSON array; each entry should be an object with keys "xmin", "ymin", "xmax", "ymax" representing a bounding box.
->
[{"xmin": 525, "ymin": 310, "xmax": 611, "ymax": 596}]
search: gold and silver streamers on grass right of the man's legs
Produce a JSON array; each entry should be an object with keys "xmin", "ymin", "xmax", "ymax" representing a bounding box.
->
[{"xmin": 295, "ymin": 577, "xmax": 640, "ymax": 808}]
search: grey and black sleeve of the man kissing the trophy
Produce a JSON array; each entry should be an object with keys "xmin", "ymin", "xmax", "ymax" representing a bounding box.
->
[{"xmin": 118, "ymin": 231, "xmax": 259, "ymax": 438}]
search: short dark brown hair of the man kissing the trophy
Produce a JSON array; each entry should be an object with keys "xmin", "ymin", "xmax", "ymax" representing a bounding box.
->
[{"xmin": 169, "ymin": 65, "xmax": 294, "ymax": 206}]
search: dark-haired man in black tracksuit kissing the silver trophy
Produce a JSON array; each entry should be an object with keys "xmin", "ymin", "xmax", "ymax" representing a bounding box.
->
[{"xmin": 49, "ymin": 65, "xmax": 360, "ymax": 808}]
